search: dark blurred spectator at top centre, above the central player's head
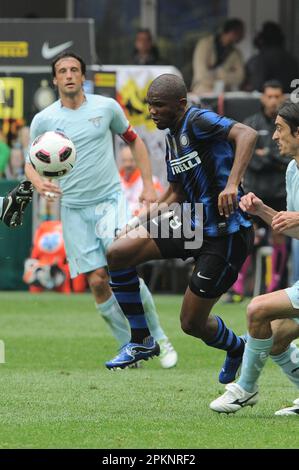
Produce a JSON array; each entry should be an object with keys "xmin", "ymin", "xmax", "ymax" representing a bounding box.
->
[{"xmin": 133, "ymin": 28, "xmax": 163, "ymax": 65}]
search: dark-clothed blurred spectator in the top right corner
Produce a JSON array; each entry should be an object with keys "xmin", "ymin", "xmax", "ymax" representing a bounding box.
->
[{"xmin": 244, "ymin": 21, "xmax": 299, "ymax": 93}]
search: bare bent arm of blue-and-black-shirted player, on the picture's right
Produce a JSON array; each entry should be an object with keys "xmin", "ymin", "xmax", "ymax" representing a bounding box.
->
[{"xmin": 218, "ymin": 123, "xmax": 258, "ymax": 217}]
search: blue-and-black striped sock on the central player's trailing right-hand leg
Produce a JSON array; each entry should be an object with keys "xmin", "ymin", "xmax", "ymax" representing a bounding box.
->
[{"xmin": 205, "ymin": 315, "xmax": 245, "ymax": 357}]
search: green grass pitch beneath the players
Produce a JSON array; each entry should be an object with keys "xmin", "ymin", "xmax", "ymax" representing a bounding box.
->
[{"xmin": 0, "ymin": 293, "xmax": 299, "ymax": 449}]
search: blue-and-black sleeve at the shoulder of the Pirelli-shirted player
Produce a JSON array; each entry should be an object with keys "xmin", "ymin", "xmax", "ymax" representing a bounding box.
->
[{"xmin": 191, "ymin": 110, "xmax": 236, "ymax": 139}]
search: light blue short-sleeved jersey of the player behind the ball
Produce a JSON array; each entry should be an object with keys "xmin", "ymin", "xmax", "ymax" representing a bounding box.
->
[{"xmin": 27, "ymin": 94, "xmax": 129, "ymax": 208}]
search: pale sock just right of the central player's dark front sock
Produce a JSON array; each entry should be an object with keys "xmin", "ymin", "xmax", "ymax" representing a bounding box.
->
[{"xmin": 139, "ymin": 278, "xmax": 167, "ymax": 341}]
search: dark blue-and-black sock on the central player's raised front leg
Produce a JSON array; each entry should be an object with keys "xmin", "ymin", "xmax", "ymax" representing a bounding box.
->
[{"xmin": 110, "ymin": 268, "xmax": 150, "ymax": 343}]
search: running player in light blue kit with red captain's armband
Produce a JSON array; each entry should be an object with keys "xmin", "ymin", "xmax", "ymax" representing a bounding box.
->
[{"xmin": 26, "ymin": 52, "xmax": 177, "ymax": 368}]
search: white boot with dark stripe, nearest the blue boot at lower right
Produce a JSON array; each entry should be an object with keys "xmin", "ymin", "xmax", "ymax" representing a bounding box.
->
[{"xmin": 210, "ymin": 383, "xmax": 258, "ymax": 413}]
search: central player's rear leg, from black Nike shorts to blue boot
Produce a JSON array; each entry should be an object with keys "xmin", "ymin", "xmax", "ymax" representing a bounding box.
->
[{"xmin": 181, "ymin": 228, "xmax": 253, "ymax": 383}]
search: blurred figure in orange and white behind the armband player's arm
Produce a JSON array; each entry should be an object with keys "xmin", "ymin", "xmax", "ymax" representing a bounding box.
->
[{"xmin": 119, "ymin": 145, "xmax": 164, "ymax": 215}]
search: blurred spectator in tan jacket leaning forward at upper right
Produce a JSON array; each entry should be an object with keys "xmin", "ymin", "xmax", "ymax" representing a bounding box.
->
[{"xmin": 191, "ymin": 18, "xmax": 244, "ymax": 94}]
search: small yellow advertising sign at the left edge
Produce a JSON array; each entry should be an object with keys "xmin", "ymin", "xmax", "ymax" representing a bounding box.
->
[{"xmin": 0, "ymin": 77, "xmax": 24, "ymax": 119}]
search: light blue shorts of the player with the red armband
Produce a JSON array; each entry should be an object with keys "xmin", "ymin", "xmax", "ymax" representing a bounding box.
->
[{"xmin": 61, "ymin": 192, "xmax": 130, "ymax": 278}]
